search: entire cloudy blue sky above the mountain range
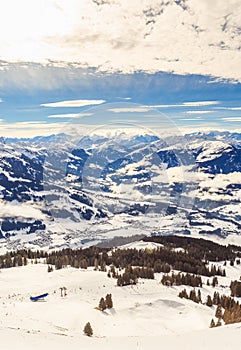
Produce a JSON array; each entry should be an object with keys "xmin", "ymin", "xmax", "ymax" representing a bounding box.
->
[{"xmin": 0, "ymin": 0, "xmax": 241, "ymax": 137}]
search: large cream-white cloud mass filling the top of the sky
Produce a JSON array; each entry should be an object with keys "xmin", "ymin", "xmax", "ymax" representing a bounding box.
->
[{"xmin": 0, "ymin": 0, "xmax": 241, "ymax": 81}]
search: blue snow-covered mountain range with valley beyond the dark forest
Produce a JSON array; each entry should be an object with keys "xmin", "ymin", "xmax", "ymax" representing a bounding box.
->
[{"xmin": 0, "ymin": 132, "xmax": 241, "ymax": 249}]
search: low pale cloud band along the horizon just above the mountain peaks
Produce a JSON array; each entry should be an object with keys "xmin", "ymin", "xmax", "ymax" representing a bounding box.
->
[{"xmin": 0, "ymin": 117, "xmax": 241, "ymax": 138}]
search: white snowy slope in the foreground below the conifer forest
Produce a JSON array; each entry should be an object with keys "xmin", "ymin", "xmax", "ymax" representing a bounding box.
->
[{"xmin": 0, "ymin": 263, "xmax": 241, "ymax": 350}]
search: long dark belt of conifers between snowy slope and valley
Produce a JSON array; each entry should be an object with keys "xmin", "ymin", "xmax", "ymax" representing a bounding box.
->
[{"xmin": 0, "ymin": 236, "xmax": 236, "ymax": 277}]
